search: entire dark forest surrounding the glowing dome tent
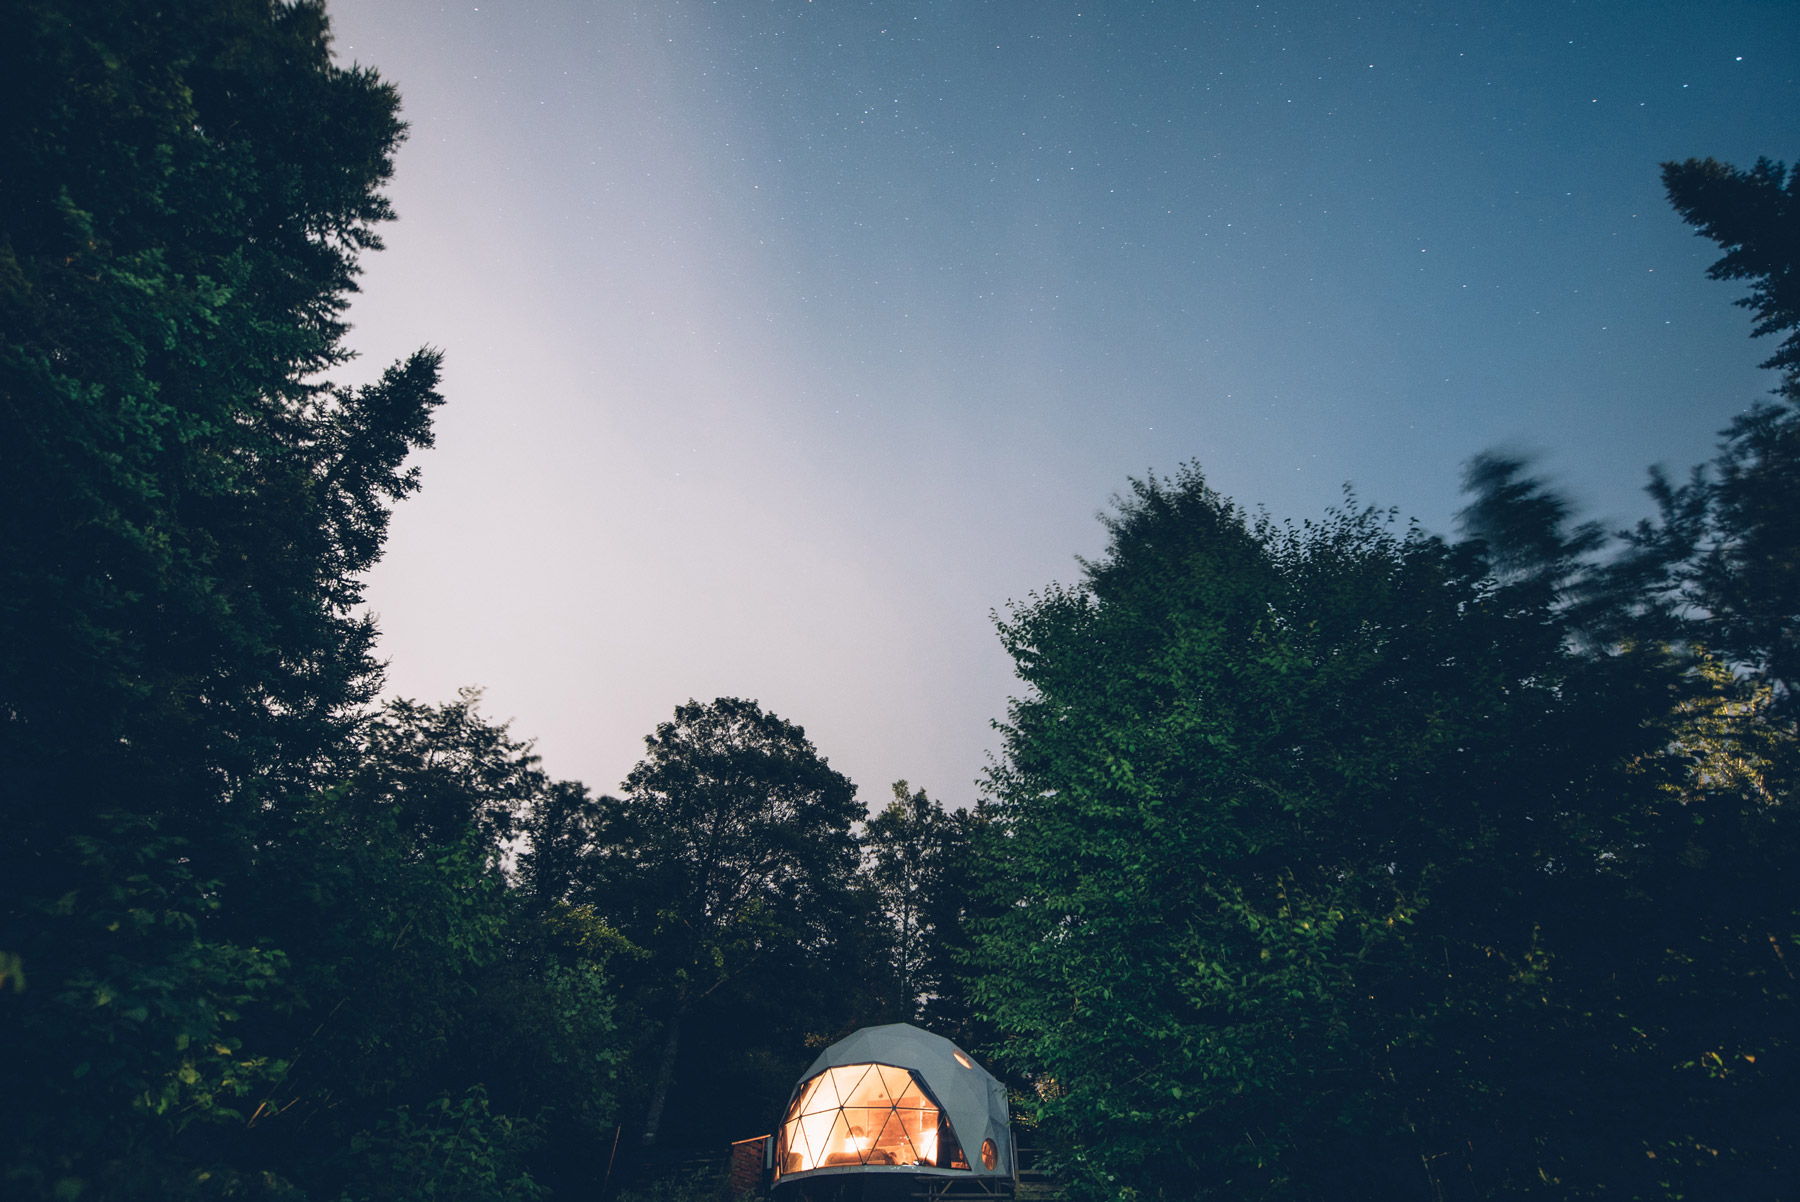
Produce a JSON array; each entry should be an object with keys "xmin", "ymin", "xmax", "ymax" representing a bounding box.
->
[{"xmin": 0, "ymin": 0, "xmax": 1800, "ymax": 1202}]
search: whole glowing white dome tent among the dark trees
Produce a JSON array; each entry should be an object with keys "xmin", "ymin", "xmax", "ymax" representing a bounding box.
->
[{"xmin": 772, "ymin": 1022, "xmax": 1013, "ymax": 1200}]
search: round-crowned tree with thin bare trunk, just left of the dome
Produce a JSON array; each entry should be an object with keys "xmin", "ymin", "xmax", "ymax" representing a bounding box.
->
[{"xmin": 590, "ymin": 696, "xmax": 862, "ymax": 1146}]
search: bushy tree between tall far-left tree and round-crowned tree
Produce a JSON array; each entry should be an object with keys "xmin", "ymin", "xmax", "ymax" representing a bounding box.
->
[{"xmin": 212, "ymin": 691, "xmax": 630, "ymax": 1198}]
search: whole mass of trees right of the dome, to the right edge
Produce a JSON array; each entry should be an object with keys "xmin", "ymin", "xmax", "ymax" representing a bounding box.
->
[{"xmin": 968, "ymin": 160, "xmax": 1800, "ymax": 1200}]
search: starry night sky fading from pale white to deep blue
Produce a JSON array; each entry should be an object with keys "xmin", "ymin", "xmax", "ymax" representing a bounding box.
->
[{"xmin": 331, "ymin": 0, "xmax": 1800, "ymax": 806}]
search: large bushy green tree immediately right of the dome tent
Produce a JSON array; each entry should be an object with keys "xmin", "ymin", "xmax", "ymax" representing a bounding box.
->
[{"xmin": 976, "ymin": 464, "xmax": 1679, "ymax": 1198}]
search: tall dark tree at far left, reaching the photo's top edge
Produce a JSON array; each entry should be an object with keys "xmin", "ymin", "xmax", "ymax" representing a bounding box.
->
[{"xmin": 0, "ymin": 0, "xmax": 439, "ymax": 1197}]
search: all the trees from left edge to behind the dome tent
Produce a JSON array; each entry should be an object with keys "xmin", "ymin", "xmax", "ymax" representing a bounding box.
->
[{"xmin": 0, "ymin": 0, "xmax": 977, "ymax": 1202}]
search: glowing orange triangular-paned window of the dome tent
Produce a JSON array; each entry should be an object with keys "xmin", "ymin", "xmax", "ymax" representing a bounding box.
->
[{"xmin": 776, "ymin": 1063, "xmax": 968, "ymax": 1173}]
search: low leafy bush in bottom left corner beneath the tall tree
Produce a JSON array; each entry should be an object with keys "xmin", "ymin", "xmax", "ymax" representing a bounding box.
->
[{"xmin": 7, "ymin": 813, "xmax": 286, "ymax": 1197}]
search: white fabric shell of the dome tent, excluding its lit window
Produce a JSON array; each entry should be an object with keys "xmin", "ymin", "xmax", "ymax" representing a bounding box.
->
[{"xmin": 796, "ymin": 1022, "xmax": 1013, "ymax": 1177}]
